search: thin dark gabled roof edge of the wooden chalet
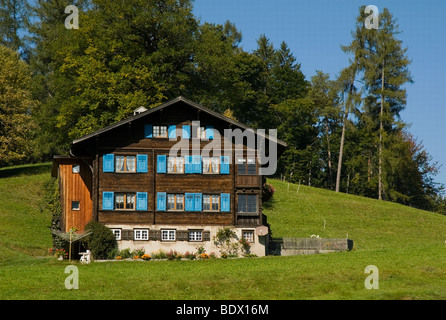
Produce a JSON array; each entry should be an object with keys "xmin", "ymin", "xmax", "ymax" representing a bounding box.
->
[{"xmin": 72, "ymin": 96, "xmax": 287, "ymax": 147}]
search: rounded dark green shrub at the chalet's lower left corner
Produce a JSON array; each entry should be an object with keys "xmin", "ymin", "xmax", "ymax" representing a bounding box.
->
[{"xmin": 85, "ymin": 220, "xmax": 117, "ymax": 259}]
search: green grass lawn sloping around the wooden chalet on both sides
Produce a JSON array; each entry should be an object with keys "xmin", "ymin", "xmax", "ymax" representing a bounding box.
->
[{"xmin": 0, "ymin": 164, "xmax": 446, "ymax": 300}]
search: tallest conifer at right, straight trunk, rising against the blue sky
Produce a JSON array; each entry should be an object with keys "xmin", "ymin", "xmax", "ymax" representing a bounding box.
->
[{"xmin": 363, "ymin": 8, "xmax": 412, "ymax": 199}]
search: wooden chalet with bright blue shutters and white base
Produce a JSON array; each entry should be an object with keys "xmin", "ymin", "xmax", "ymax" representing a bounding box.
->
[{"xmin": 52, "ymin": 97, "xmax": 286, "ymax": 256}]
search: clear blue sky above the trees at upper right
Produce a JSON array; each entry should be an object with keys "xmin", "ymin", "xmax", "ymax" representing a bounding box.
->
[{"xmin": 194, "ymin": 0, "xmax": 446, "ymax": 190}]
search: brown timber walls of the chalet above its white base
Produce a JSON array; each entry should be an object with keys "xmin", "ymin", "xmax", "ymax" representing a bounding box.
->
[{"xmin": 53, "ymin": 97, "xmax": 285, "ymax": 231}]
